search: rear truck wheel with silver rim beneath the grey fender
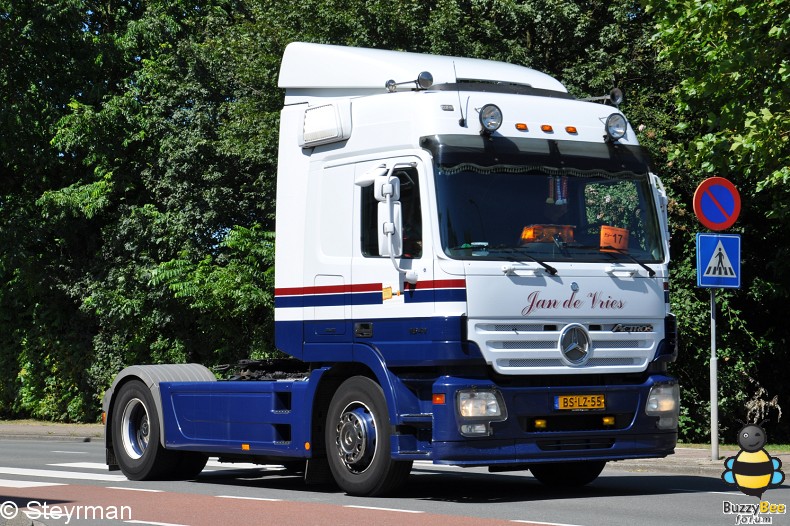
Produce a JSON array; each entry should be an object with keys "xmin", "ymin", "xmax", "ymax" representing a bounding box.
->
[{"xmin": 111, "ymin": 380, "xmax": 182, "ymax": 480}]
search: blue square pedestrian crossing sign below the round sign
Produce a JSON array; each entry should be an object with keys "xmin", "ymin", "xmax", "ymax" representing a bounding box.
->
[{"xmin": 697, "ymin": 234, "xmax": 741, "ymax": 289}]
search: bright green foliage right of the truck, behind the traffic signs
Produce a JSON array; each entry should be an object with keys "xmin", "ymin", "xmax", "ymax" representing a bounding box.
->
[{"xmin": 648, "ymin": 0, "xmax": 790, "ymax": 439}]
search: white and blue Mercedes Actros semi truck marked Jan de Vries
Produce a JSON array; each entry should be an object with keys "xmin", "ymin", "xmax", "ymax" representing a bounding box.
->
[{"xmin": 103, "ymin": 43, "xmax": 679, "ymax": 495}]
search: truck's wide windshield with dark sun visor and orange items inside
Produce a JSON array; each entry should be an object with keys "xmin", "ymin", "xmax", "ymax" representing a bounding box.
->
[{"xmin": 422, "ymin": 135, "xmax": 664, "ymax": 263}]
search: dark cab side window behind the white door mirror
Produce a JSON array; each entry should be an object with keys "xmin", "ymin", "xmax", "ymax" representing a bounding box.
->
[{"xmin": 361, "ymin": 168, "xmax": 422, "ymax": 258}]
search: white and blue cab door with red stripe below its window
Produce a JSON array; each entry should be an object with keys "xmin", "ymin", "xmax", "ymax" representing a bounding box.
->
[{"xmin": 351, "ymin": 157, "xmax": 435, "ymax": 365}]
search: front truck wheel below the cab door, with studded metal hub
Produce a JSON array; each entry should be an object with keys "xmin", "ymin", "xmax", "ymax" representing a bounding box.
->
[{"xmin": 325, "ymin": 376, "xmax": 412, "ymax": 497}]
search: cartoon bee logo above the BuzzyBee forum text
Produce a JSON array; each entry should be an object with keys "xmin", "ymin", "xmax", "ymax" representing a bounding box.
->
[{"xmin": 721, "ymin": 422, "xmax": 785, "ymax": 498}]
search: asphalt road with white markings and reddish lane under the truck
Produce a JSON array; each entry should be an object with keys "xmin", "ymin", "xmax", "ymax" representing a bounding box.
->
[{"xmin": 0, "ymin": 439, "xmax": 790, "ymax": 526}]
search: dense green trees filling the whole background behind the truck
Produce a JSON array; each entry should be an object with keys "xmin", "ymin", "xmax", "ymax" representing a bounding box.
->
[{"xmin": 0, "ymin": 0, "xmax": 790, "ymax": 444}]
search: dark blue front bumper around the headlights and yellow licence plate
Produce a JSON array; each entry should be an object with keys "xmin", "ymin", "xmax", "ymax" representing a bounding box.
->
[{"xmin": 431, "ymin": 375, "xmax": 677, "ymax": 466}]
